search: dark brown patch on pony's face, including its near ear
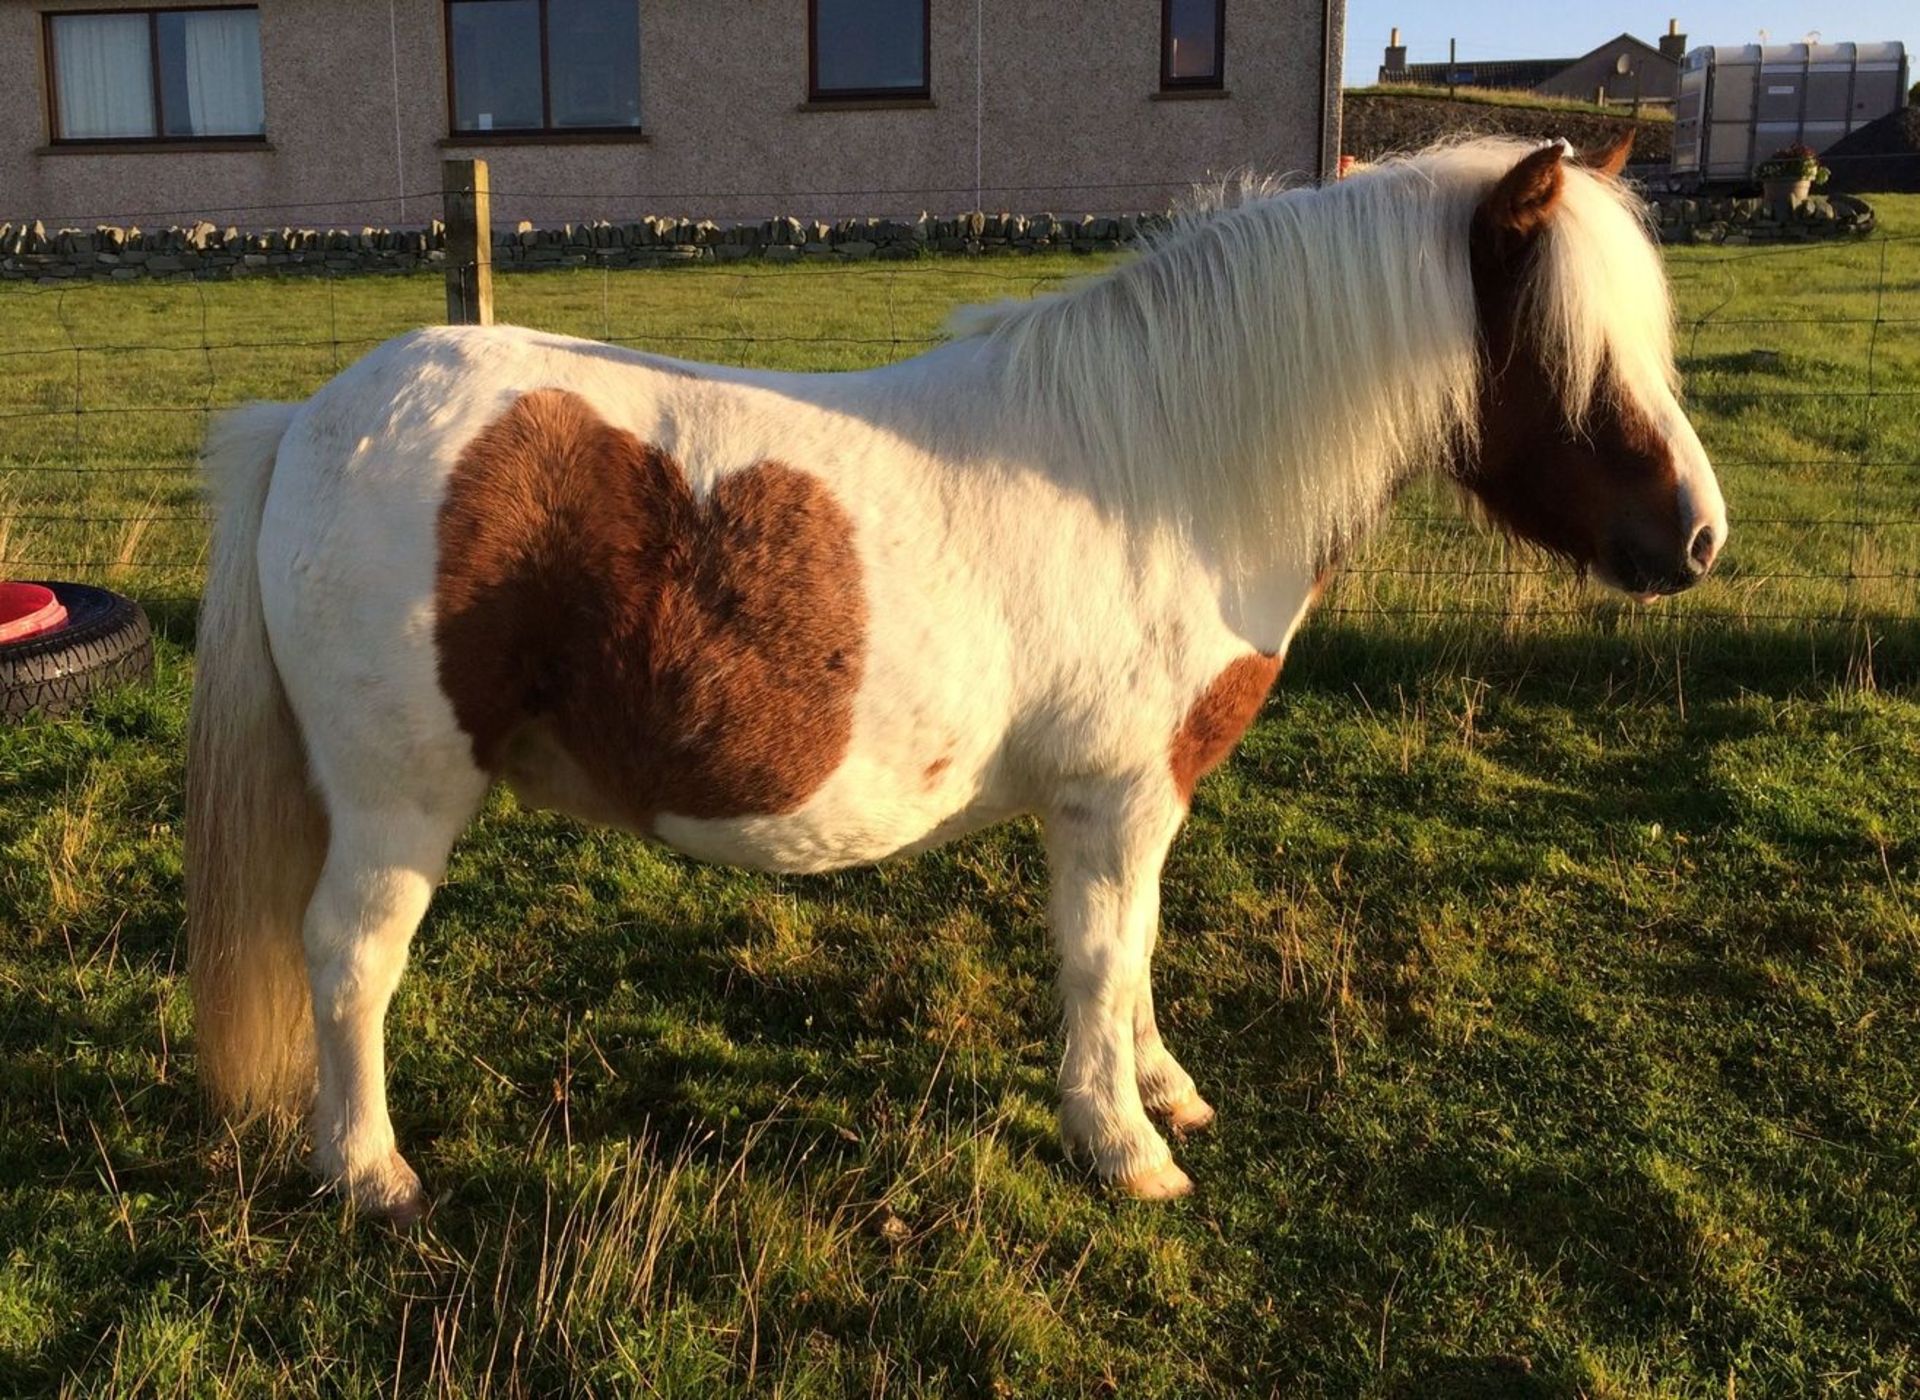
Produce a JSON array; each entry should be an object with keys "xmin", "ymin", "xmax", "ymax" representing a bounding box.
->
[{"xmin": 1457, "ymin": 146, "xmax": 1693, "ymax": 593}]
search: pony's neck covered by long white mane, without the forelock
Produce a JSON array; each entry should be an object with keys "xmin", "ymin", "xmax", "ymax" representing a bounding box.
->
[{"xmin": 962, "ymin": 163, "xmax": 1478, "ymax": 588}]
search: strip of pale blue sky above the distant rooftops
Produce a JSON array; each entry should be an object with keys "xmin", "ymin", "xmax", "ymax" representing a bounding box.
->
[{"xmin": 1346, "ymin": 0, "xmax": 1920, "ymax": 84}]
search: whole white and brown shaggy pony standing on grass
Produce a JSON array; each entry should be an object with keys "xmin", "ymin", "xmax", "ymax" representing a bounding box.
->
[{"xmin": 188, "ymin": 140, "xmax": 1726, "ymax": 1219}]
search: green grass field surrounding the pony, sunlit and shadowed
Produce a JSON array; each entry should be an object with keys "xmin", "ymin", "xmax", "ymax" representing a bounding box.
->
[{"xmin": 0, "ymin": 198, "xmax": 1920, "ymax": 1396}]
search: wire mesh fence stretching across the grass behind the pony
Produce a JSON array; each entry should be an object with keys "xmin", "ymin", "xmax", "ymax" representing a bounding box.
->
[{"xmin": 0, "ymin": 183, "xmax": 1920, "ymax": 641}]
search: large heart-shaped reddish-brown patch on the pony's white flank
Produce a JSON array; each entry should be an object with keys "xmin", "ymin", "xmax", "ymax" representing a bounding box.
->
[{"xmin": 434, "ymin": 390, "xmax": 866, "ymax": 828}]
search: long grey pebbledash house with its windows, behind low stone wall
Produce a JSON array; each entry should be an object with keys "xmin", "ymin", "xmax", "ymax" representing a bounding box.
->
[{"xmin": 0, "ymin": 0, "xmax": 1344, "ymax": 227}]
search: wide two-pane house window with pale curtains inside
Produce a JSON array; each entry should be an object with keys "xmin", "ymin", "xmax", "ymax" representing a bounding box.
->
[{"xmin": 46, "ymin": 8, "xmax": 267, "ymax": 142}]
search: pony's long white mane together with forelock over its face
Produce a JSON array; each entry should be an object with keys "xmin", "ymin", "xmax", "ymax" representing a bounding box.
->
[{"xmin": 952, "ymin": 138, "xmax": 1672, "ymax": 572}]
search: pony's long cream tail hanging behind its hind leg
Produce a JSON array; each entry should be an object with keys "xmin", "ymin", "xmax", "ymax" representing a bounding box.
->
[{"xmin": 186, "ymin": 403, "xmax": 326, "ymax": 1118}]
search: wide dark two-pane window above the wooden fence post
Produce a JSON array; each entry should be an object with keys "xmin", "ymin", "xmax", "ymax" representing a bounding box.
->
[{"xmin": 447, "ymin": 0, "xmax": 639, "ymax": 133}]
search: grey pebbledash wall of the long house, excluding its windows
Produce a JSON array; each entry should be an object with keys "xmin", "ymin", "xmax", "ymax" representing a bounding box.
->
[{"xmin": 0, "ymin": 0, "xmax": 1340, "ymax": 227}]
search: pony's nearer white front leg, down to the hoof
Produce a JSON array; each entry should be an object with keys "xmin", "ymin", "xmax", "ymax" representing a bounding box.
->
[{"xmin": 1046, "ymin": 782, "xmax": 1192, "ymax": 1198}]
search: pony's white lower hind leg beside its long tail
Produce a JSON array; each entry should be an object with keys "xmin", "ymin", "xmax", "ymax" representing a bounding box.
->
[{"xmin": 303, "ymin": 797, "xmax": 478, "ymax": 1223}]
